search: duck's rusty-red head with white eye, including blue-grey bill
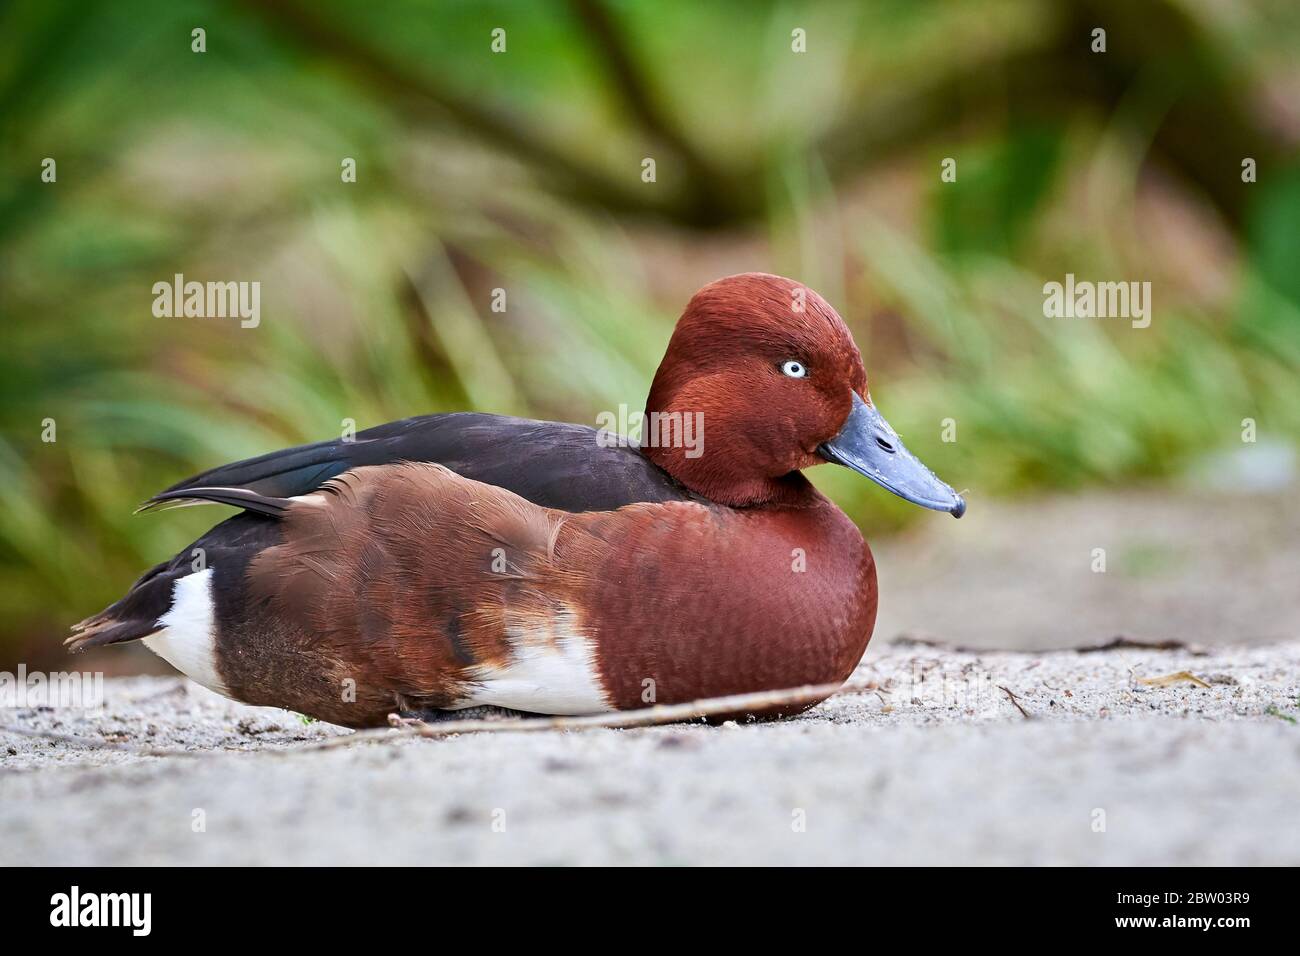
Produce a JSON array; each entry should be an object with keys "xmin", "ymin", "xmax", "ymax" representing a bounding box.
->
[{"xmin": 642, "ymin": 272, "xmax": 966, "ymax": 518}]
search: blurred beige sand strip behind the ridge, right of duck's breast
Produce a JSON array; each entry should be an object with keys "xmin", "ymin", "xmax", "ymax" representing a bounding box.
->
[{"xmin": 871, "ymin": 488, "xmax": 1300, "ymax": 650}]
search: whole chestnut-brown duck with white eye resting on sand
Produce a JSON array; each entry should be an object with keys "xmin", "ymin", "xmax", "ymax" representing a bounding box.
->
[{"xmin": 66, "ymin": 273, "xmax": 966, "ymax": 728}]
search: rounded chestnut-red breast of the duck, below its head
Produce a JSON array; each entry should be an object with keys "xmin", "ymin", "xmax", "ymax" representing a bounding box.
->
[{"xmin": 560, "ymin": 498, "xmax": 876, "ymax": 709}]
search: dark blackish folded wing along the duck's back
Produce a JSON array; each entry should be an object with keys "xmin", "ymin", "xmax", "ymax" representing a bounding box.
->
[{"xmin": 144, "ymin": 412, "xmax": 694, "ymax": 511}]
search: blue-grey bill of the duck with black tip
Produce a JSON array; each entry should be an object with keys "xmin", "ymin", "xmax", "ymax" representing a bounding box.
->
[{"xmin": 818, "ymin": 393, "xmax": 966, "ymax": 518}]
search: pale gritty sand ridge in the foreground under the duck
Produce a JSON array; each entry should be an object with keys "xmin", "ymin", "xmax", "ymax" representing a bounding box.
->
[{"xmin": 0, "ymin": 644, "xmax": 1300, "ymax": 865}]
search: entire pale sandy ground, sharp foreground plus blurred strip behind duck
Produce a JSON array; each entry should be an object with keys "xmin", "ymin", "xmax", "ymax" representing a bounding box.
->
[{"xmin": 0, "ymin": 492, "xmax": 1300, "ymax": 865}]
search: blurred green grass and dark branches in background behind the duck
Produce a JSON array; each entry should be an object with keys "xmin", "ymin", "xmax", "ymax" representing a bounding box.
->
[{"xmin": 0, "ymin": 0, "xmax": 1300, "ymax": 662}]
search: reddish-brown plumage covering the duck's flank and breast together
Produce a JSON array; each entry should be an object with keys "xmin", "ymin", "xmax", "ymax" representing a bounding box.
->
[{"xmin": 225, "ymin": 464, "xmax": 875, "ymax": 726}]
